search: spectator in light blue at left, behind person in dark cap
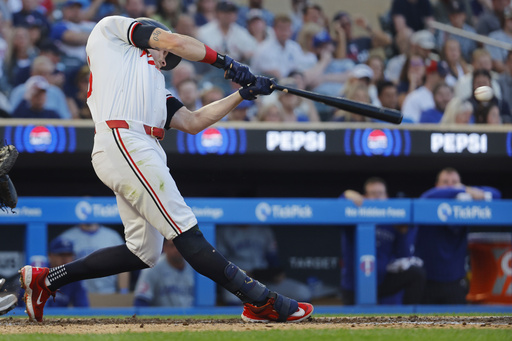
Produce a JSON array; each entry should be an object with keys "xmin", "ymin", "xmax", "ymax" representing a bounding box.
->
[{"xmin": 10, "ymin": 56, "xmax": 71, "ymax": 119}]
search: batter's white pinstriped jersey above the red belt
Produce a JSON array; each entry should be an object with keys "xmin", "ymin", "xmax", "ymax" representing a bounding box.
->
[{"xmin": 86, "ymin": 16, "xmax": 169, "ymax": 128}]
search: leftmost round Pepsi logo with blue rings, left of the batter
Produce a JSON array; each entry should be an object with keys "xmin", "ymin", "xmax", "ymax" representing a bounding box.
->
[{"xmin": 4, "ymin": 125, "xmax": 76, "ymax": 154}]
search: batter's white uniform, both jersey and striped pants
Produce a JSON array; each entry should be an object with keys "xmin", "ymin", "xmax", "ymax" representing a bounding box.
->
[{"xmin": 86, "ymin": 16, "xmax": 197, "ymax": 267}]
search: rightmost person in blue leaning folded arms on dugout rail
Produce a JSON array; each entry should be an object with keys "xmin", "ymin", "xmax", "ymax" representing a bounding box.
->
[{"xmin": 416, "ymin": 168, "xmax": 501, "ymax": 304}]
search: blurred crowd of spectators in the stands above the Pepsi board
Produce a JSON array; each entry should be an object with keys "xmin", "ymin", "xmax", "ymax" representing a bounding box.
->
[{"xmin": 0, "ymin": 0, "xmax": 512, "ymax": 124}]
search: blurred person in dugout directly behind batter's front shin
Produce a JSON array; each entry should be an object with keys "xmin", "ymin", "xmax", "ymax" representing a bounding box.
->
[{"xmin": 217, "ymin": 225, "xmax": 311, "ymax": 304}]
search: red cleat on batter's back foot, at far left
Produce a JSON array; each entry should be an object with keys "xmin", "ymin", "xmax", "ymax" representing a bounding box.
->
[{"xmin": 19, "ymin": 265, "xmax": 56, "ymax": 322}]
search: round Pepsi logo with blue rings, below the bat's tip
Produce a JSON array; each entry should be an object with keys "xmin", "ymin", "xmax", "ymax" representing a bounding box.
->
[{"xmin": 344, "ymin": 128, "xmax": 411, "ymax": 156}]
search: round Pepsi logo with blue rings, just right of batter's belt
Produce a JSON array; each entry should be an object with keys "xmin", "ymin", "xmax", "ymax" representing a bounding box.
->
[{"xmin": 176, "ymin": 127, "xmax": 247, "ymax": 155}]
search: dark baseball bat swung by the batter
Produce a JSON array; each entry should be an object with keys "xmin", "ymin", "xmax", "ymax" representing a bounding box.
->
[{"xmin": 272, "ymin": 84, "xmax": 403, "ymax": 124}]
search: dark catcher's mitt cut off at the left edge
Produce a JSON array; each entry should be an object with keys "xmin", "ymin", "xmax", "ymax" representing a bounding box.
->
[{"xmin": 0, "ymin": 145, "xmax": 19, "ymax": 209}]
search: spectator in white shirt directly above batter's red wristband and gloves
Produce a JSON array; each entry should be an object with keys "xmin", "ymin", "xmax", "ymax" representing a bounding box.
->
[{"xmin": 197, "ymin": 0, "xmax": 257, "ymax": 62}]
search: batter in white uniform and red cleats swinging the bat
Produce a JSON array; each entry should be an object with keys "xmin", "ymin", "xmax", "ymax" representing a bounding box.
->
[{"xmin": 20, "ymin": 16, "xmax": 313, "ymax": 322}]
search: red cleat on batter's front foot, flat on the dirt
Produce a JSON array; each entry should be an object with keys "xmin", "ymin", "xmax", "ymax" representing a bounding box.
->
[{"xmin": 242, "ymin": 294, "xmax": 314, "ymax": 323}]
